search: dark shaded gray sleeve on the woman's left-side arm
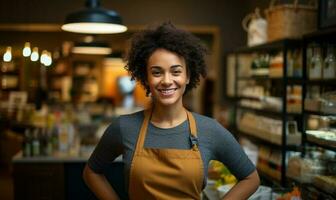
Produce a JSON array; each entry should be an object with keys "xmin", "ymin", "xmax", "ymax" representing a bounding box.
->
[{"xmin": 88, "ymin": 117, "xmax": 123, "ymax": 173}]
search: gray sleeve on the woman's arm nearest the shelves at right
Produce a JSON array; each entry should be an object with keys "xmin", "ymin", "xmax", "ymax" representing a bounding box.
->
[{"xmin": 213, "ymin": 121, "xmax": 255, "ymax": 180}]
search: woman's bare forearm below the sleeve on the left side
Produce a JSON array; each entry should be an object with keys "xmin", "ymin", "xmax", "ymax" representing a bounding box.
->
[{"xmin": 83, "ymin": 164, "xmax": 119, "ymax": 200}]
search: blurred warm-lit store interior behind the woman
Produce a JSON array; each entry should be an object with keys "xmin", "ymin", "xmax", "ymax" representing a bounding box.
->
[{"xmin": 0, "ymin": 0, "xmax": 336, "ymax": 200}]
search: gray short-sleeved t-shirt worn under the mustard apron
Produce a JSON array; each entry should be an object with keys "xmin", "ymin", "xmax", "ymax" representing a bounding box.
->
[{"xmin": 88, "ymin": 111, "xmax": 255, "ymax": 189}]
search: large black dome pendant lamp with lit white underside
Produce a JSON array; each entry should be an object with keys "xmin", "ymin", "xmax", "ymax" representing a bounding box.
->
[{"xmin": 62, "ymin": 0, "xmax": 127, "ymax": 34}]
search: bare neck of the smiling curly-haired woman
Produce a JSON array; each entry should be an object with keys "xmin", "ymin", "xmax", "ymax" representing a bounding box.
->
[{"xmin": 151, "ymin": 103, "xmax": 187, "ymax": 128}]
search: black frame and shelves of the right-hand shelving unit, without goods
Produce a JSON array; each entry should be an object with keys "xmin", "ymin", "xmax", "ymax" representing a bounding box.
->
[{"xmin": 225, "ymin": 29, "xmax": 336, "ymax": 192}]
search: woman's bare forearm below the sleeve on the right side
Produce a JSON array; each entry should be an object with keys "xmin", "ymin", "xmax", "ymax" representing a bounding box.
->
[{"xmin": 223, "ymin": 170, "xmax": 260, "ymax": 200}]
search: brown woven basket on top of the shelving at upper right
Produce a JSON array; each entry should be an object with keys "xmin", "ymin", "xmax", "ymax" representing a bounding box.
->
[{"xmin": 265, "ymin": 0, "xmax": 317, "ymax": 41}]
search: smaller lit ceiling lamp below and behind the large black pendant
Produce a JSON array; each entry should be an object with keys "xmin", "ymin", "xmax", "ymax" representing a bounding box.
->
[{"xmin": 72, "ymin": 42, "xmax": 112, "ymax": 55}]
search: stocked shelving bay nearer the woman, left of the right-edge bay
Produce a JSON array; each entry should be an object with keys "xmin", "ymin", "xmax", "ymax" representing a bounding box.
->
[{"xmin": 228, "ymin": 39, "xmax": 303, "ymax": 186}]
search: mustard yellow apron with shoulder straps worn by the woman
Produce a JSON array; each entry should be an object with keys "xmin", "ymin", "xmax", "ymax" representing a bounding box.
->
[{"xmin": 129, "ymin": 109, "xmax": 204, "ymax": 200}]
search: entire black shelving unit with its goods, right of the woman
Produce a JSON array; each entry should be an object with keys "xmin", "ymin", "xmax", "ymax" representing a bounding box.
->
[{"xmin": 223, "ymin": 29, "xmax": 336, "ymax": 196}]
